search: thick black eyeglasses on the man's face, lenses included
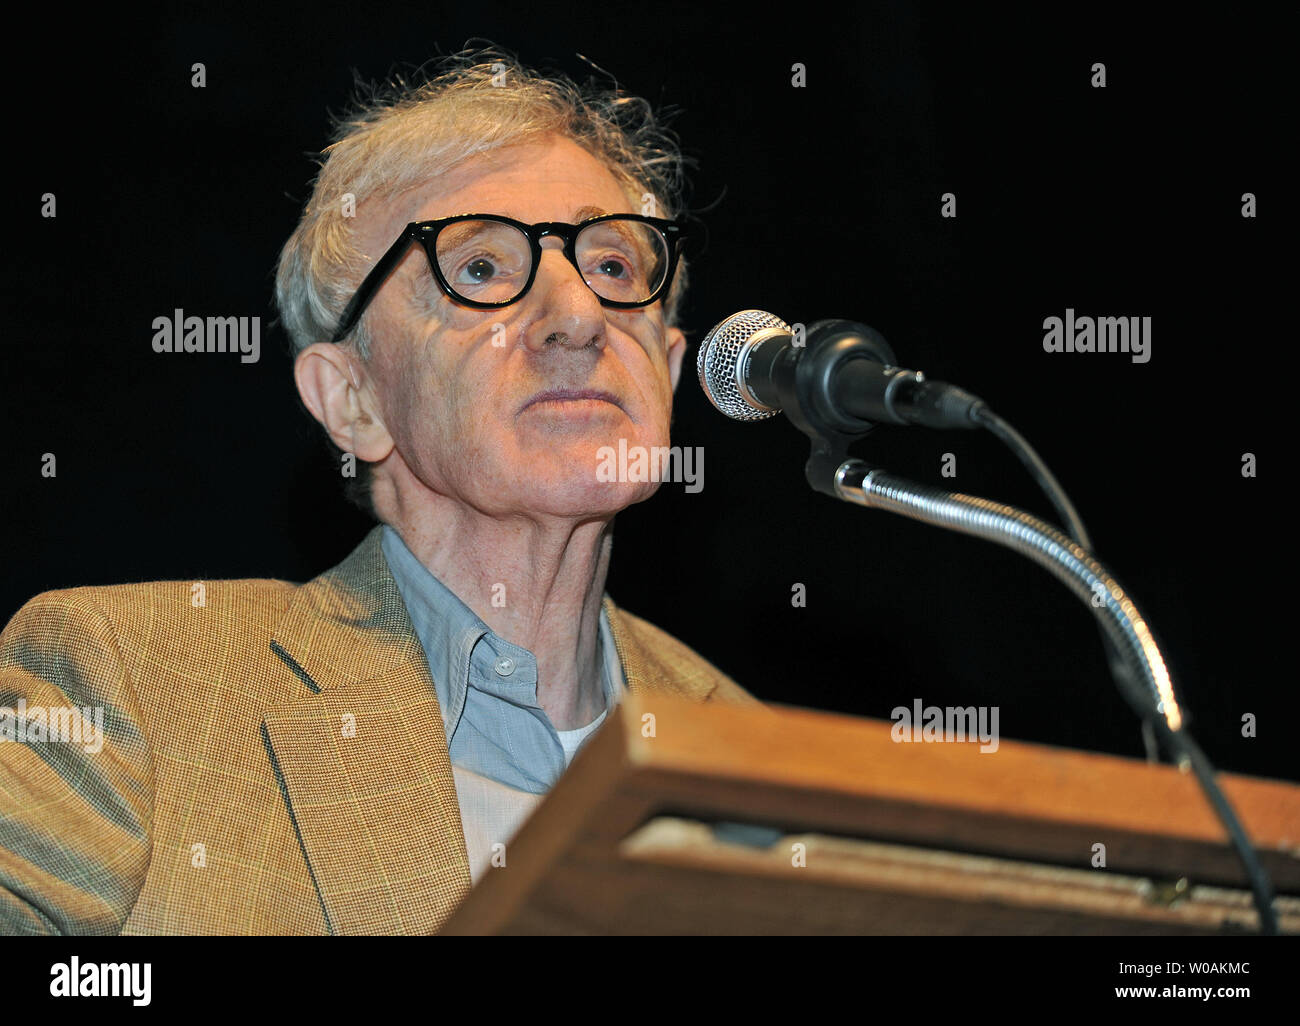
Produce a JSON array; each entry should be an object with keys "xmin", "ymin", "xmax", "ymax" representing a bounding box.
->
[{"xmin": 330, "ymin": 213, "xmax": 685, "ymax": 342}]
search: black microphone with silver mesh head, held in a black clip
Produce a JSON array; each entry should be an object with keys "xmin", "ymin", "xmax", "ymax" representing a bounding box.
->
[{"xmin": 696, "ymin": 309, "xmax": 984, "ymax": 436}]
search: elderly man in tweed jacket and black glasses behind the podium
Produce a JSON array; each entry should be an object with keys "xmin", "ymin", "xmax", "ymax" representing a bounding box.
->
[{"xmin": 0, "ymin": 53, "xmax": 754, "ymax": 934}]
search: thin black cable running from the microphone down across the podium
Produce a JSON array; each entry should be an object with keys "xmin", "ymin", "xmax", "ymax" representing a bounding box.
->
[{"xmin": 971, "ymin": 404, "xmax": 1278, "ymax": 935}]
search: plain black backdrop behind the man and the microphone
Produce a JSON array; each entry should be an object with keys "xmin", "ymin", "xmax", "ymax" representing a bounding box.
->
[{"xmin": 0, "ymin": 3, "xmax": 1300, "ymax": 779}]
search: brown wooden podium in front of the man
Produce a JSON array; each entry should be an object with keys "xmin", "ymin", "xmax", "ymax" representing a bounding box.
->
[{"xmin": 441, "ymin": 693, "xmax": 1300, "ymax": 935}]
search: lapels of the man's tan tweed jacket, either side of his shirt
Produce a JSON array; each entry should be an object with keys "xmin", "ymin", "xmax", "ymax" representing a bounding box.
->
[{"xmin": 263, "ymin": 527, "xmax": 716, "ymax": 934}]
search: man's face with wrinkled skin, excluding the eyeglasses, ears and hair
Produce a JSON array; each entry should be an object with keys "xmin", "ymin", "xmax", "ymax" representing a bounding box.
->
[{"xmin": 351, "ymin": 137, "xmax": 685, "ymax": 516}]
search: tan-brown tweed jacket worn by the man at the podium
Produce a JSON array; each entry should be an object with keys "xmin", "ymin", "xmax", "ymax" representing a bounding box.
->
[{"xmin": 0, "ymin": 528, "xmax": 757, "ymax": 934}]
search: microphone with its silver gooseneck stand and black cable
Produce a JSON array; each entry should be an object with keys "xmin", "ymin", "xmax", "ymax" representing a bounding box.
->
[{"xmin": 698, "ymin": 311, "xmax": 1278, "ymax": 934}]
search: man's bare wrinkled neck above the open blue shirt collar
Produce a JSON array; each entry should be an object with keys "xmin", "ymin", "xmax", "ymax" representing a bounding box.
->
[{"xmin": 387, "ymin": 506, "xmax": 614, "ymax": 731}]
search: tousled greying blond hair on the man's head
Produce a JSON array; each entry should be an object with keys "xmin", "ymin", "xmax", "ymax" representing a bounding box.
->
[{"xmin": 276, "ymin": 47, "xmax": 688, "ymax": 515}]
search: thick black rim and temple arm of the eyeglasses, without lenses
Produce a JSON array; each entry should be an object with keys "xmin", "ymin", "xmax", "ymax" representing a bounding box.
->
[{"xmin": 330, "ymin": 213, "xmax": 686, "ymax": 343}]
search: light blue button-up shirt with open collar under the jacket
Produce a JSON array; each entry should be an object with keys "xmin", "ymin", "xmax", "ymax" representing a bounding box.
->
[{"xmin": 382, "ymin": 525, "xmax": 627, "ymax": 795}]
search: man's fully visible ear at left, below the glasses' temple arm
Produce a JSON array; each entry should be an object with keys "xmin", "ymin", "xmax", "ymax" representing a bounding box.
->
[{"xmin": 294, "ymin": 342, "xmax": 394, "ymax": 463}]
